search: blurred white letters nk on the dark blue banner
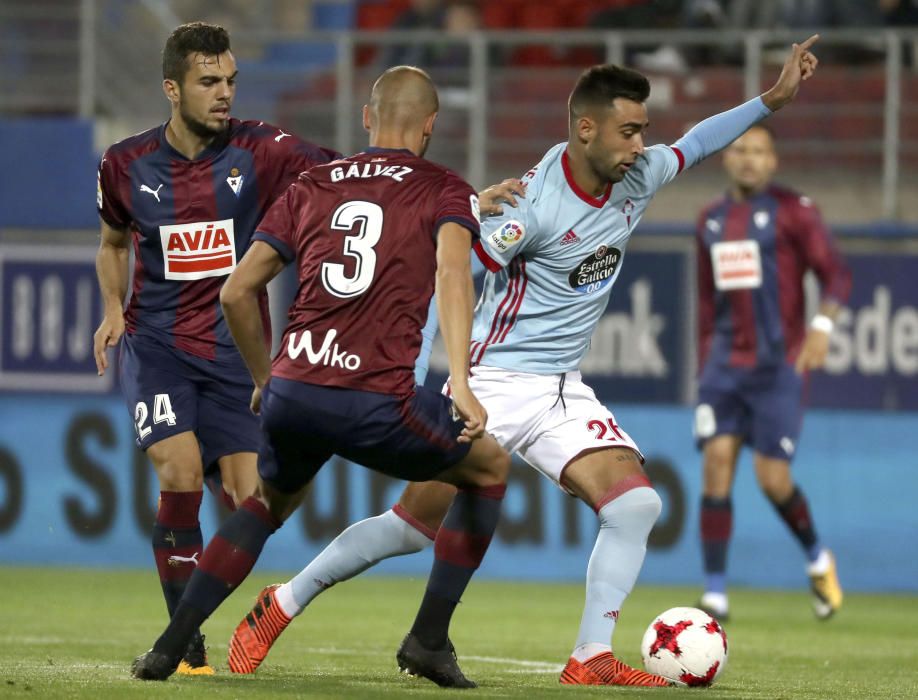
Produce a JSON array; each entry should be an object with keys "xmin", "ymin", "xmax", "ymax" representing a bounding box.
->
[{"xmin": 580, "ymin": 277, "xmax": 670, "ymax": 379}]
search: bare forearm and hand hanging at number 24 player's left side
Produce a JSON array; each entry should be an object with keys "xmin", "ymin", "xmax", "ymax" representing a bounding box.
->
[{"xmin": 93, "ymin": 221, "xmax": 131, "ymax": 377}]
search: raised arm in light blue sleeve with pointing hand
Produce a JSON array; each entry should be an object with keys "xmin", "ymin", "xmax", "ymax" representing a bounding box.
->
[{"xmin": 673, "ymin": 34, "xmax": 819, "ymax": 168}]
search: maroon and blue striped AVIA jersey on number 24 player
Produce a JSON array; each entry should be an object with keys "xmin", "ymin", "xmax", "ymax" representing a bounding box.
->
[{"xmin": 96, "ymin": 119, "xmax": 338, "ymax": 362}]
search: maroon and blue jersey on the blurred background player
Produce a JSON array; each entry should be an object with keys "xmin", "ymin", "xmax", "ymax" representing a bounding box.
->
[{"xmin": 696, "ymin": 185, "xmax": 851, "ymax": 367}]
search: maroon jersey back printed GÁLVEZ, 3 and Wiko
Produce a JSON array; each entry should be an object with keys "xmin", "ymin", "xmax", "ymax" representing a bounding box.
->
[{"xmin": 255, "ymin": 148, "xmax": 479, "ymax": 397}]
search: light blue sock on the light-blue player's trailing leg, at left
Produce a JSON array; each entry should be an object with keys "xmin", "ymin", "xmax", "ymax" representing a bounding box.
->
[{"xmin": 284, "ymin": 510, "xmax": 433, "ymax": 617}]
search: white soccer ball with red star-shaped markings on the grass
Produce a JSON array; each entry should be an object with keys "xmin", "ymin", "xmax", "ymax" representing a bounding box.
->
[{"xmin": 641, "ymin": 608, "xmax": 727, "ymax": 686}]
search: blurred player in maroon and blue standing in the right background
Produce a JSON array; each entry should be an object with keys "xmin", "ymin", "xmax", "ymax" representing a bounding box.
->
[{"xmin": 695, "ymin": 126, "xmax": 851, "ymax": 620}]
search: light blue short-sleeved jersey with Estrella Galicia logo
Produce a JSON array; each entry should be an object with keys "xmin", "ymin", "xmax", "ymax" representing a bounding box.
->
[{"xmin": 471, "ymin": 143, "xmax": 684, "ymax": 374}]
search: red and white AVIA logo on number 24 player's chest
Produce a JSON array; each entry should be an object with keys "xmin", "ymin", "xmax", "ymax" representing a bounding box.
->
[{"xmin": 159, "ymin": 219, "xmax": 236, "ymax": 280}]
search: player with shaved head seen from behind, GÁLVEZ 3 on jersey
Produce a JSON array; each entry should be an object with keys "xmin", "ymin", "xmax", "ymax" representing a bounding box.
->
[{"xmin": 132, "ymin": 66, "xmax": 510, "ymax": 688}]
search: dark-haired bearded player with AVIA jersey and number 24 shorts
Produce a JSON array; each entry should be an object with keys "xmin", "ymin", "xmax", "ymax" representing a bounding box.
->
[{"xmin": 95, "ymin": 23, "xmax": 337, "ymax": 674}]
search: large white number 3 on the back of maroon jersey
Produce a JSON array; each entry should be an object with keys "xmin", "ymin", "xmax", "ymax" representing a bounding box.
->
[{"xmin": 322, "ymin": 201, "xmax": 383, "ymax": 299}]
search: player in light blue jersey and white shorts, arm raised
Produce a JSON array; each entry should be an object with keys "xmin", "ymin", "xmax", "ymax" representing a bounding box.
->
[{"xmin": 230, "ymin": 36, "xmax": 818, "ymax": 686}]
